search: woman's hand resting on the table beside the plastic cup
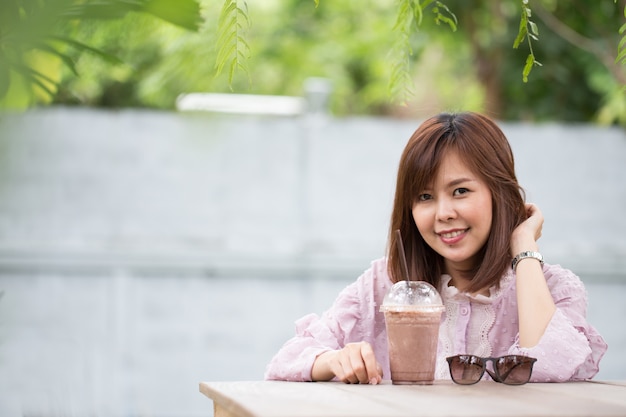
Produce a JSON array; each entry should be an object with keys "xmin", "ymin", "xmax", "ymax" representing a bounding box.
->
[{"xmin": 311, "ymin": 342, "xmax": 383, "ymax": 385}]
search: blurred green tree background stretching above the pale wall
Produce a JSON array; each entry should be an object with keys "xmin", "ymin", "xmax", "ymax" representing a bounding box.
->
[{"xmin": 0, "ymin": 0, "xmax": 626, "ymax": 126}]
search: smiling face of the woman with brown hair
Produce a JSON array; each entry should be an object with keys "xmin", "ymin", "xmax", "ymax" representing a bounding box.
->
[{"xmin": 413, "ymin": 151, "xmax": 492, "ymax": 273}]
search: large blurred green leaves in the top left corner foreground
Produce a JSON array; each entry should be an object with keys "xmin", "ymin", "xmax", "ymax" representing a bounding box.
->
[{"xmin": 0, "ymin": 0, "xmax": 202, "ymax": 108}]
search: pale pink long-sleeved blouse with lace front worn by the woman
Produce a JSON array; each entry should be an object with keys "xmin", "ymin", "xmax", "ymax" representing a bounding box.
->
[{"xmin": 265, "ymin": 258, "xmax": 607, "ymax": 382}]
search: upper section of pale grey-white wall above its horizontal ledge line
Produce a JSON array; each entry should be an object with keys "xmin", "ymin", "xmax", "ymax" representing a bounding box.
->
[{"xmin": 0, "ymin": 109, "xmax": 626, "ymax": 274}]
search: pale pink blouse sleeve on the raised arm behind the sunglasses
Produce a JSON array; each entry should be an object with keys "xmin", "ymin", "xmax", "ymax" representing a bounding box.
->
[{"xmin": 509, "ymin": 266, "xmax": 607, "ymax": 382}]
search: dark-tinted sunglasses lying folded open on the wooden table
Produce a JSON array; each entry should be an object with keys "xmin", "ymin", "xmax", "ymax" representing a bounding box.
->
[{"xmin": 446, "ymin": 355, "xmax": 537, "ymax": 385}]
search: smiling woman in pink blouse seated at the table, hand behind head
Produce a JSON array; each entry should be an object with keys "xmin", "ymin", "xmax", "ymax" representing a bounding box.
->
[{"xmin": 265, "ymin": 113, "xmax": 607, "ymax": 384}]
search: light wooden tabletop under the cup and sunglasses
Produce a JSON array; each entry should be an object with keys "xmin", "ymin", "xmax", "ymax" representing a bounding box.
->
[{"xmin": 200, "ymin": 381, "xmax": 626, "ymax": 417}]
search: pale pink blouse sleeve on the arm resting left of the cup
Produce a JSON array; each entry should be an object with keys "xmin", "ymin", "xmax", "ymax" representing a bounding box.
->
[{"xmin": 265, "ymin": 277, "xmax": 363, "ymax": 381}]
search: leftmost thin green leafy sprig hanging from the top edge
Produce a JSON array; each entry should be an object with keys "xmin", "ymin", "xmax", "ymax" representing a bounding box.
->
[{"xmin": 215, "ymin": 0, "xmax": 250, "ymax": 86}]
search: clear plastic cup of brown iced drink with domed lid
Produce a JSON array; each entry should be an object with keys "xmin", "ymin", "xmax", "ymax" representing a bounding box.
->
[{"xmin": 380, "ymin": 281, "xmax": 444, "ymax": 385}]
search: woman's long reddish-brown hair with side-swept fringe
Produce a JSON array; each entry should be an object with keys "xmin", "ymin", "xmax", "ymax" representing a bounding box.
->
[{"xmin": 387, "ymin": 112, "xmax": 527, "ymax": 292}]
